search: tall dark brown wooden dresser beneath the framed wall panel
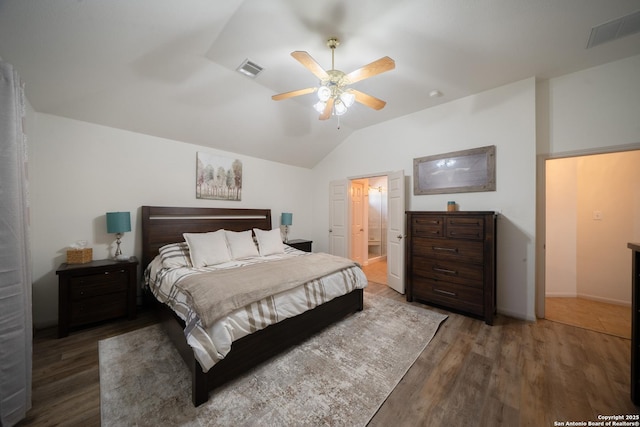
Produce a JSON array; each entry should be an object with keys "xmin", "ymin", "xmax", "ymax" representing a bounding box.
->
[{"xmin": 406, "ymin": 211, "xmax": 496, "ymax": 325}]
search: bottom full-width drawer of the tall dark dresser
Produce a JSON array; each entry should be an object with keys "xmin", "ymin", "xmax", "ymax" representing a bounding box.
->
[{"xmin": 412, "ymin": 277, "xmax": 484, "ymax": 316}]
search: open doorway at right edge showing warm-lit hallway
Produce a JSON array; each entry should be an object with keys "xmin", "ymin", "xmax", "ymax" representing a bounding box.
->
[{"xmin": 545, "ymin": 150, "xmax": 640, "ymax": 338}]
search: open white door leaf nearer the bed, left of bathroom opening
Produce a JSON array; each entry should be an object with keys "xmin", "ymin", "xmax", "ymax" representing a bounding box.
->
[{"xmin": 329, "ymin": 179, "xmax": 349, "ymax": 258}]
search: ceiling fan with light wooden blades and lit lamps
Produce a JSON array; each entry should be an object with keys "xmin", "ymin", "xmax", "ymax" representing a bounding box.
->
[{"xmin": 271, "ymin": 38, "xmax": 396, "ymax": 120}]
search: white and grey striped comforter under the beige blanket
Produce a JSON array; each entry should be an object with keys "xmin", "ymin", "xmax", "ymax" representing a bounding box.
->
[{"xmin": 145, "ymin": 246, "xmax": 367, "ymax": 372}]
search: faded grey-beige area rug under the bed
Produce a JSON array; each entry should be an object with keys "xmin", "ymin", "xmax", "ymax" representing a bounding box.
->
[{"xmin": 99, "ymin": 292, "xmax": 447, "ymax": 426}]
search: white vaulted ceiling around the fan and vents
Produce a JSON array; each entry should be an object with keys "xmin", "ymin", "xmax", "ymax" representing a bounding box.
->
[{"xmin": 0, "ymin": 0, "xmax": 640, "ymax": 167}]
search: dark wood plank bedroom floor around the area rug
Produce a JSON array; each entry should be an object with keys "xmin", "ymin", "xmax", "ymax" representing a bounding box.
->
[{"xmin": 19, "ymin": 283, "xmax": 640, "ymax": 426}]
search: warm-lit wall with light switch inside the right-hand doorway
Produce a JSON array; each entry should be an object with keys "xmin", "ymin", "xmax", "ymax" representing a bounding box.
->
[{"xmin": 576, "ymin": 151, "xmax": 640, "ymax": 306}]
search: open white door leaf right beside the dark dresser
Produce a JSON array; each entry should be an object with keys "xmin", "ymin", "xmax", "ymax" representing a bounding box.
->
[{"xmin": 387, "ymin": 170, "xmax": 406, "ymax": 294}]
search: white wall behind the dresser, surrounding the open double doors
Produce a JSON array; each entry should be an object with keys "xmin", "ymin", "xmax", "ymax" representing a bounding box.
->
[{"xmin": 313, "ymin": 78, "xmax": 536, "ymax": 320}]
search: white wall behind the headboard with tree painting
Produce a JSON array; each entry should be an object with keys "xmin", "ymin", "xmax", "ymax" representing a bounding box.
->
[{"xmin": 28, "ymin": 114, "xmax": 312, "ymax": 328}]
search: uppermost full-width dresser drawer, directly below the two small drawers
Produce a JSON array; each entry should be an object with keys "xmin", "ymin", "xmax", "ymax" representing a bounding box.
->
[{"xmin": 413, "ymin": 237, "xmax": 484, "ymax": 264}]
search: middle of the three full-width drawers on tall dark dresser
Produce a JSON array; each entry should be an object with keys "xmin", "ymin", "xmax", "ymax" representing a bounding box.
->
[{"xmin": 412, "ymin": 256, "xmax": 484, "ymax": 289}]
